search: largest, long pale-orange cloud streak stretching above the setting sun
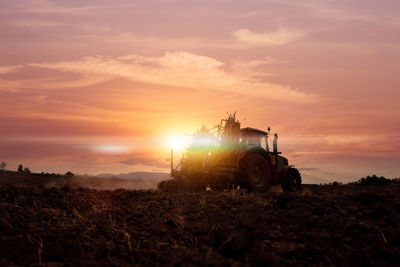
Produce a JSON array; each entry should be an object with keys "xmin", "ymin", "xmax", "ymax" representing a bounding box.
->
[{"xmin": 30, "ymin": 52, "xmax": 319, "ymax": 103}]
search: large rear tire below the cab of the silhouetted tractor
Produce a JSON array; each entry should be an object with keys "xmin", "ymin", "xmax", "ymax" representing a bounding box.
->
[{"xmin": 240, "ymin": 153, "xmax": 272, "ymax": 191}]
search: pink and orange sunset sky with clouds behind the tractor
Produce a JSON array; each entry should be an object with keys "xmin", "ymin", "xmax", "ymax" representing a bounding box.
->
[{"xmin": 0, "ymin": 0, "xmax": 400, "ymax": 183}]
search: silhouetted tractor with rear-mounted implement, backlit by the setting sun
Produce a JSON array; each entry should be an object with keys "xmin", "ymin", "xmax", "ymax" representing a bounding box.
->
[{"xmin": 158, "ymin": 113, "xmax": 301, "ymax": 191}]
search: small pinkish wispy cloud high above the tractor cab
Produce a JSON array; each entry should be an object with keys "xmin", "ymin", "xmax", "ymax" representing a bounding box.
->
[{"xmin": 233, "ymin": 28, "xmax": 304, "ymax": 46}]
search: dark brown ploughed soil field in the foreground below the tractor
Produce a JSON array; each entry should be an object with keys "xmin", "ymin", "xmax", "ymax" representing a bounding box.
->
[{"xmin": 0, "ymin": 182, "xmax": 400, "ymax": 266}]
